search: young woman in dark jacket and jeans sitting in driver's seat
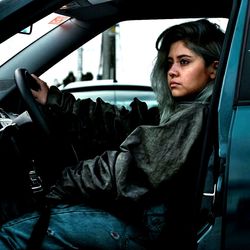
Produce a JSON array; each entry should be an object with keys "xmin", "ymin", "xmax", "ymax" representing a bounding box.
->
[{"xmin": 0, "ymin": 19, "xmax": 224, "ymax": 250}]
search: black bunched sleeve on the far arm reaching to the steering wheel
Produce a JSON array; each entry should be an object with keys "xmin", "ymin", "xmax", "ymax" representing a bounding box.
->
[{"xmin": 46, "ymin": 86, "xmax": 159, "ymax": 159}]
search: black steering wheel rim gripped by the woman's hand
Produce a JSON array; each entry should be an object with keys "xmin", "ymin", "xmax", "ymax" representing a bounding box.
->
[{"xmin": 14, "ymin": 68, "xmax": 51, "ymax": 136}]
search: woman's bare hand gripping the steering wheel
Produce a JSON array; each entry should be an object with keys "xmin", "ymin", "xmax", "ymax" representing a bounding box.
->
[{"xmin": 30, "ymin": 74, "xmax": 49, "ymax": 105}]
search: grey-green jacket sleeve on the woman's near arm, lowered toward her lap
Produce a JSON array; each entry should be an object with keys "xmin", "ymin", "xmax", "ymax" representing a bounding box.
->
[{"xmin": 47, "ymin": 103, "xmax": 207, "ymax": 205}]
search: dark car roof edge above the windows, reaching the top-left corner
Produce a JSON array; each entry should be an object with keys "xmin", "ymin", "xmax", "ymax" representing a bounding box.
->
[{"xmin": 0, "ymin": 0, "xmax": 233, "ymax": 42}]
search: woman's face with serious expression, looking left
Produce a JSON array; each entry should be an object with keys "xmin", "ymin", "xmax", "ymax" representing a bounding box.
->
[{"xmin": 167, "ymin": 41, "xmax": 218, "ymax": 97}]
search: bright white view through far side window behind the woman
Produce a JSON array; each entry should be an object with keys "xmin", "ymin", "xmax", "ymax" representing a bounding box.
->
[{"xmin": 41, "ymin": 18, "xmax": 228, "ymax": 85}]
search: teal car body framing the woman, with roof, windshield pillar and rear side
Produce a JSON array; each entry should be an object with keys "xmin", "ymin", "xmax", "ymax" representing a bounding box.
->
[{"xmin": 0, "ymin": 0, "xmax": 250, "ymax": 250}]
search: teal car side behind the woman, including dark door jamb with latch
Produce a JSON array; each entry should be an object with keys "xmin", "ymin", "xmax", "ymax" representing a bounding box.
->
[{"xmin": 195, "ymin": 0, "xmax": 250, "ymax": 250}]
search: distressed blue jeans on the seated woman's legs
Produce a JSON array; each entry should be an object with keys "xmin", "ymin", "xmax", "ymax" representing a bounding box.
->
[{"xmin": 0, "ymin": 204, "xmax": 167, "ymax": 250}]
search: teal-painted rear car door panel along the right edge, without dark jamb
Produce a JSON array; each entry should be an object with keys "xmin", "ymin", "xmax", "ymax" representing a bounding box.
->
[{"xmin": 219, "ymin": 0, "xmax": 250, "ymax": 250}]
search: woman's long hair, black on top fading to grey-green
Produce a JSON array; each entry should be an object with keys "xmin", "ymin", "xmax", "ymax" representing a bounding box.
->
[{"xmin": 151, "ymin": 19, "xmax": 224, "ymax": 123}]
